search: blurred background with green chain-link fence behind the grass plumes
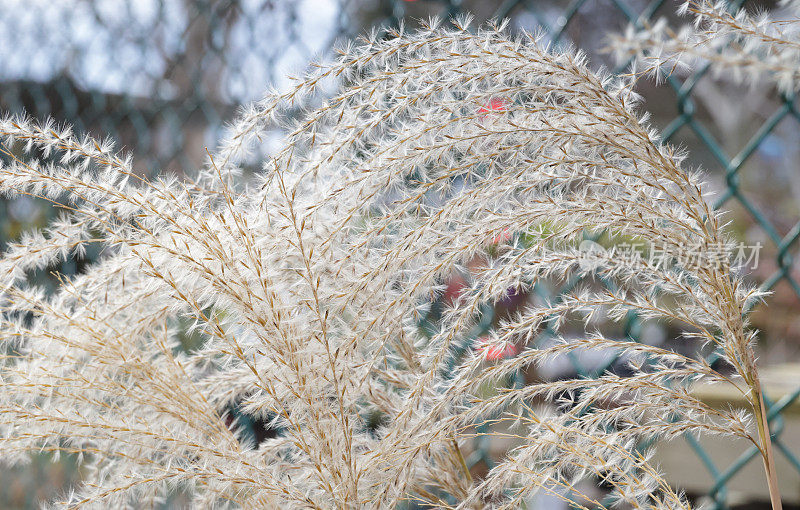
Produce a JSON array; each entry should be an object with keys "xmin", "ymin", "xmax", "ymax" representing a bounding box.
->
[{"xmin": 0, "ymin": 0, "xmax": 800, "ymax": 508}]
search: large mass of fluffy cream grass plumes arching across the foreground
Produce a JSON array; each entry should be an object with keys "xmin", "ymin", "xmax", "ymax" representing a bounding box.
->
[{"xmin": 0, "ymin": 16, "xmax": 780, "ymax": 509}]
